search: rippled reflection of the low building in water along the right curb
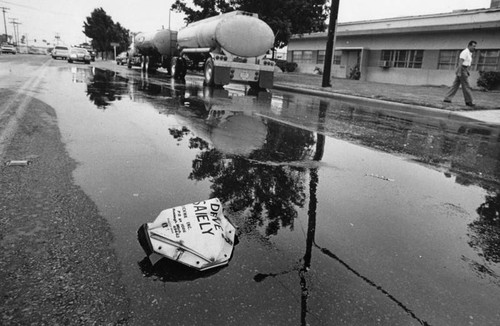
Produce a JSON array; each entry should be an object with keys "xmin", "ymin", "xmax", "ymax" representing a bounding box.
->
[{"xmin": 273, "ymin": 94, "xmax": 500, "ymax": 189}]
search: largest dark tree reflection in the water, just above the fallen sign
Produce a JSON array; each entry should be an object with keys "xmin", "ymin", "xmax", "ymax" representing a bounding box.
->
[{"xmin": 189, "ymin": 122, "xmax": 315, "ymax": 235}]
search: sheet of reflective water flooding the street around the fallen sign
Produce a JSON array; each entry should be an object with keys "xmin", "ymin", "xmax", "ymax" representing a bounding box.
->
[{"xmin": 1, "ymin": 56, "xmax": 500, "ymax": 325}]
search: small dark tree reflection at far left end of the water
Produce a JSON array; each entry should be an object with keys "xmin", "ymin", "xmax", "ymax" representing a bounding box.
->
[{"xmin": 87, "ymin": 69, "xmax": 128, "ymax": 109}]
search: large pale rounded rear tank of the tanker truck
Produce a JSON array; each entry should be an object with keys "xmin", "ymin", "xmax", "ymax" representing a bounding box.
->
[{"xmin": 177, "ymin": 11, "xmax": 274, "ymax": 57}]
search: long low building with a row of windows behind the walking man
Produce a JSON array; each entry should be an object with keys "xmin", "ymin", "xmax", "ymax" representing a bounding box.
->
[{"xmin": 287, "ymin": 0, "xmax": 500, "ymax": 85}]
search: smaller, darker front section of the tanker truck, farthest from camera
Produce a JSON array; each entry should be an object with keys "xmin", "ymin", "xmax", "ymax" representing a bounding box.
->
[{"xmin": 127, "ymin": 29, "xmax": 179, "ymax": 73}]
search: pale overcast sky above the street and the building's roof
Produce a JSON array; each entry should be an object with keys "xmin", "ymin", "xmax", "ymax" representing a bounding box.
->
[{"xmin": 0, "ymin": 0, "xmax": 491, "ymax": 45}]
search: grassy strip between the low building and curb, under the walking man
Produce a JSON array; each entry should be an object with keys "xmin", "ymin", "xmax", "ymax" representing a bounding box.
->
[{"xmin": 274, "ymin": 72, "xmax": 500, "ymax": 112}]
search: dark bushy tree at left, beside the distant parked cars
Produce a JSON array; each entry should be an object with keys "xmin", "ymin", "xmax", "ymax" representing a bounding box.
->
[{"xmin": 83, "ymin": 8, "xmax": 130, "ymax": 57}]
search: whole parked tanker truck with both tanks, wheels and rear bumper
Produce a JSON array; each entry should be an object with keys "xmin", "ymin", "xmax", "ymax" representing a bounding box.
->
[{"xmin": 132, "ymin": 11, "xmax": 275, "ymax": 88}]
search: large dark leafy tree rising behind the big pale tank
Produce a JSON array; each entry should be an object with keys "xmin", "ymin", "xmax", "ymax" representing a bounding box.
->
[{"xmin": 172, "ymin": 0, "xmax": 328, "ymax": 48}]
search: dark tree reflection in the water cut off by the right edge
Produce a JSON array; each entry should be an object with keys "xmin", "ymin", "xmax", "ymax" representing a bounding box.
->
[{"xmin": 469, "ymin": 193, "xmax": 500, "ymax": 263}]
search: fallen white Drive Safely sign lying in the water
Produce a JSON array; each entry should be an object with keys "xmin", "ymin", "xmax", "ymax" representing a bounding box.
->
[{"xmin": 137, "ymin": 198, "xmax": 236, "ymax": 271}]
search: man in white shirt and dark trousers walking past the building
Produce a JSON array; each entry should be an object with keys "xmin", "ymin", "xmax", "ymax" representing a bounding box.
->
[{"xmin": 444, "ymin": 41, "xmax": 477, "ymax": 107}]
